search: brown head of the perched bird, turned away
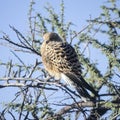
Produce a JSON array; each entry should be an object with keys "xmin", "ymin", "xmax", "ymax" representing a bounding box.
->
[{"xmin": 43, "ymin": 32, "xmax": 62, "ymax": 41}]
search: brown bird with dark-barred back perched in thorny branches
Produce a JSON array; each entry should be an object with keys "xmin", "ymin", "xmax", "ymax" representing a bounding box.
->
[{"xmin": 40, "ymin": 32, "xmax": 98, "ymax": 101}]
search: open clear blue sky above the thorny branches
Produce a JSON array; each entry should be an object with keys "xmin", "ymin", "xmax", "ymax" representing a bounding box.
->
[{"xmin": 0, "ymin": 0, "xmax": 104, "ymax": 61}]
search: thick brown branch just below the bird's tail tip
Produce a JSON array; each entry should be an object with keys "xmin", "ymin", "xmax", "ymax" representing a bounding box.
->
[{"xmin": 48, "ymin": 97, "xmax": 120, "ymax": 120}]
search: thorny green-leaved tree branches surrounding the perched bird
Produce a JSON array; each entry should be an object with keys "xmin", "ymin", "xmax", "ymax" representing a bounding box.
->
[{"xmin": 0, "ymin": 0, "xmax": 120, "ymax": 120}]
